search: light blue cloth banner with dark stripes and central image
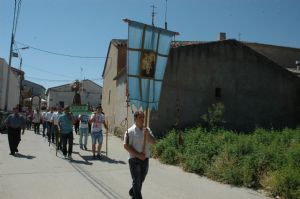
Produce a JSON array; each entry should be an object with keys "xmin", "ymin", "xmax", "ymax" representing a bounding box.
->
[{"xmin": 125, "ymin": 20, "xmax": 177, "ymax": 111}]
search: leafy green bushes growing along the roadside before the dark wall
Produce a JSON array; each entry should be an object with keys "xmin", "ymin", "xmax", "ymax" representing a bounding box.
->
[{"xmin": 153, "ymin": 127, "xmax": 300, "ymax": 199}]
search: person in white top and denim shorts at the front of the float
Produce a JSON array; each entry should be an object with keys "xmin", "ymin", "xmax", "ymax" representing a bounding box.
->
[{"xmin": 89, "ymin": 105, "xmax": 108, "ymax": 159}]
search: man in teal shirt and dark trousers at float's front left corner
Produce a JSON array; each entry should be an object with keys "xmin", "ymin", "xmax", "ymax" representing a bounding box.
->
[{"xmin": 58, "ymin": 106, "xmax": 75, "ymax": 160}]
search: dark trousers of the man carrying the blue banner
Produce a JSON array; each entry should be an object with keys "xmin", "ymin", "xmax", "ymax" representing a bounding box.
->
[{"xmin": 129, "ymin": 158, "xmax": 149, "ymax": 199}]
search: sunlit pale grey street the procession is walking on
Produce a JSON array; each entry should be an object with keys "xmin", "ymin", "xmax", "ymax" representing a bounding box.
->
[{"xmin": 0, "ymin": 130, "xmax": 268, "ymax": 199}]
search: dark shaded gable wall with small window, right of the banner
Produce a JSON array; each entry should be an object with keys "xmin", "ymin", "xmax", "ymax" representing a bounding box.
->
[{"xmin": 151, "ymin": 40, "xmax": 300, "ymax": 134}]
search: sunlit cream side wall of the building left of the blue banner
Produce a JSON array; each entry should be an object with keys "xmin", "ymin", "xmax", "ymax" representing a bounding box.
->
[{"xmin": 102, "ymin": 40, "xmax": 133, "ymax": 135}]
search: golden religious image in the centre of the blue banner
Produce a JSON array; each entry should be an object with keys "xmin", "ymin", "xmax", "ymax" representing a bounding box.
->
[{"xmin": 140, "ymin": 51, "xmax": 155, "ymax": 79}]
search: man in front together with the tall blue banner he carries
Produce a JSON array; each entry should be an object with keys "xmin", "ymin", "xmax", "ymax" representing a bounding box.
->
[{"xmin": 124, "ymin": 19, "xmax": 178, "ymax": 199}]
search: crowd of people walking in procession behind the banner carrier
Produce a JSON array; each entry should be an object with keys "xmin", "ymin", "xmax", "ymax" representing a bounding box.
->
[{"xmin": 5, "ymin": 105, "xmax": 108, "ymax": 159}]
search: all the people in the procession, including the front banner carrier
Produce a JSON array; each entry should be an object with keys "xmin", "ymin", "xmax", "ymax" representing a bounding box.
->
[{"xmin": 5, "ymin": 106, "xmax": 155, "ymax": 199}]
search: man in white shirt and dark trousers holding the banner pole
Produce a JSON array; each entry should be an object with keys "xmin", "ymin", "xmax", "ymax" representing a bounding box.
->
[{"xmin": 124, "ymin": 111, "xmax": 155, "ymax": 199}]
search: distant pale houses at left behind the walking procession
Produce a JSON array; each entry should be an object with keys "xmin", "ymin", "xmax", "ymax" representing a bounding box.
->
[{"xmin": 0, "ymin": 58, "xmax": 102, "ymax": 111}]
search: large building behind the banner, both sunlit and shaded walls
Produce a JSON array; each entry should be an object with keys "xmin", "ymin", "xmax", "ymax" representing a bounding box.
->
[{"xmin": 102, "ymin": 38, "xmax": 300, "ymax": 134}]
